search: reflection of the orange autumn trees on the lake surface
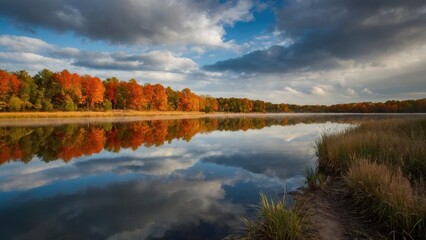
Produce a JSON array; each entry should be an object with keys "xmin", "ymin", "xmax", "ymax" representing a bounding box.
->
[{"xmin": 0, "ymin": 115, "xmax": 400, "ymax": 164}]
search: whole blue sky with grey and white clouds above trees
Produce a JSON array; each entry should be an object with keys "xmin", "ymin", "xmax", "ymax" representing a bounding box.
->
[{"xmin": 0, "ymin": 0, "xmax": 426, "ymax": 104}]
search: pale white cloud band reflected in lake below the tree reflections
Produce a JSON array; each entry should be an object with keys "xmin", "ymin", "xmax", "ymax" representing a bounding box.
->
[{"xmin": 0, "ymin": 148, "xmax": 206, "ymax": 191}]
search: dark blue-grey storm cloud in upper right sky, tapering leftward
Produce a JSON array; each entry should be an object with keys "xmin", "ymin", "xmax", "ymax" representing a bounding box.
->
[{"xmin": 204, "ymin": 0, "xmax": 426, "ymax": 73}]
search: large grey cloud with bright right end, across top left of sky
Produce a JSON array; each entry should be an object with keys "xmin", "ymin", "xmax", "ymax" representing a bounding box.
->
[{"xmin": 0, "ymin": 0, "xmax": 254, "ymax": 47}]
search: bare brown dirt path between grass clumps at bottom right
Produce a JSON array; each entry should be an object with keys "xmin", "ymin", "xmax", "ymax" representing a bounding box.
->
[{"xmin": 293, "ymin": 178, "xmax": 385, "ymax": 240}]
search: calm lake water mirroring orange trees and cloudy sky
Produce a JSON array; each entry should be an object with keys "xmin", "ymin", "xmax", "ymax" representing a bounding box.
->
[{"xmin": 0, "ymin": 115, "xmax": 412, "ymax": 239}]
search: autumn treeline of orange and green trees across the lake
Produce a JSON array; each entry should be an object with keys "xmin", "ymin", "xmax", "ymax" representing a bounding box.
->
[{"xmin": 0, "ymin": 69, "xmax": 426, "ymax": 113}]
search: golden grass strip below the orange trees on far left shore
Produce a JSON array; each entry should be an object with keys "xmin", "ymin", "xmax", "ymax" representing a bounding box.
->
[{"xmin": 0, "ymin": 110, "xmax": 205, "ymax": 119}]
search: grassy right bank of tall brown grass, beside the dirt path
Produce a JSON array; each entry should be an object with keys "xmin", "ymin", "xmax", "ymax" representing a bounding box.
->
[{"xmin": 316, "ymin": 119, "xmax": 426, "ymax": 239}]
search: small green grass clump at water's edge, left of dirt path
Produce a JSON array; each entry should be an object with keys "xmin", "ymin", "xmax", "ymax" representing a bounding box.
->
[{"xmin": 235, "ymin": 193, "xmax": 304, "ymax": 240}]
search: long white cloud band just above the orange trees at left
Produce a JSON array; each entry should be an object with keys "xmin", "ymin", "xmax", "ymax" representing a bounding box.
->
[{"xmin": 0, "ymin": 35, "xmax": 198, "ymax": 81}]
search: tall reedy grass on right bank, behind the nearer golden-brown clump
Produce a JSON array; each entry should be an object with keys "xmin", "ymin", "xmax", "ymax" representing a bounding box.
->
[{"xmin": 316, "ymin": 119, "xmax": 426, "ymax": 178}]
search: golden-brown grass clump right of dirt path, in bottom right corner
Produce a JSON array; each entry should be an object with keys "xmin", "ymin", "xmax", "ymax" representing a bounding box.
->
[{"xmin": 346, "ymin": 159, "xmax": 426, "ymax": 239}]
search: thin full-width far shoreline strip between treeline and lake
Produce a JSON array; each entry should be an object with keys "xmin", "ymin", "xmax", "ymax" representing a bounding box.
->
[{"xmin": 0, "ymin": 110, "xmax": 426, "ymax": 127}]
